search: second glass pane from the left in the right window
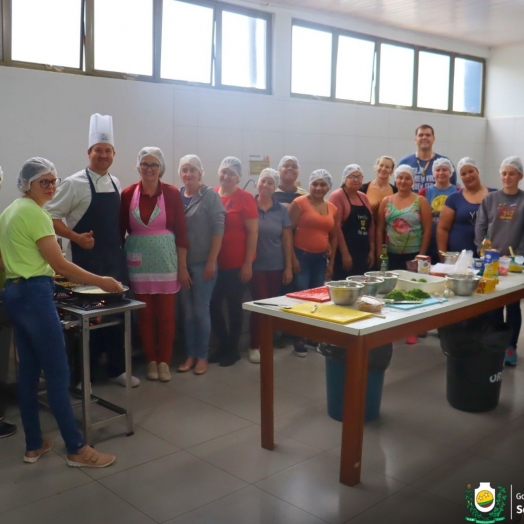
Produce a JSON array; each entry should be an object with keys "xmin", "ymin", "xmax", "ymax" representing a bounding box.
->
[{"xmin": 335, "ymin": 36, "xmax": 375, "ymax": 102}]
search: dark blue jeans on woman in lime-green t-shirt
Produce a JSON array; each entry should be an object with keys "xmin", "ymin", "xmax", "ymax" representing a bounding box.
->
[{"xmin": 3, "ymin": 277, "xmax": 85, "ymax": 454}]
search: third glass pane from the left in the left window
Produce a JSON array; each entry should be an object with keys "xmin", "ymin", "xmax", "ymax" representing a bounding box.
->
[{"xmin": 160, "ymin": 0, "xmax": 214, "ymax": 84}]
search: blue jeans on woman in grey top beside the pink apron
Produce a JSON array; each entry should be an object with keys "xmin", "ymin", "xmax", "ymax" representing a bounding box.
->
[{"xmin": 179, "ymin": 262, "xmax": 217, "ymax": 358}]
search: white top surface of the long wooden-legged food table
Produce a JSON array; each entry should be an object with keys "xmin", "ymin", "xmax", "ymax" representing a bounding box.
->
[{"xmin": 243, "ymin": 274, "xmax": 524, "ymax": 336}]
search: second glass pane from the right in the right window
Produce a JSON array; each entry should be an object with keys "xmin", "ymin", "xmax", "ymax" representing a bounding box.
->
[{"xmin": 417, "ymin": 51, "xmax": 451, "ymax": 110}]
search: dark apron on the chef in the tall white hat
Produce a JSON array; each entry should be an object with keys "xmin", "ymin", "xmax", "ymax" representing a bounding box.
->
[{"xmin": 71, "ymin": 168, "xmax": 127, "ymax": 283}]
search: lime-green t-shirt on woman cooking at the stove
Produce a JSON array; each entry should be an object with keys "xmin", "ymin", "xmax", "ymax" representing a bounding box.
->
[{"xmin": 0, "ymin": 198, "xmax": 55, "ymax": 278}]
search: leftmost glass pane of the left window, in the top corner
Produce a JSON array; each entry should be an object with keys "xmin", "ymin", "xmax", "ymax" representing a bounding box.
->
[{"xmin": 11, "ymin": 0, "xmax": 82, "ymax": 68}]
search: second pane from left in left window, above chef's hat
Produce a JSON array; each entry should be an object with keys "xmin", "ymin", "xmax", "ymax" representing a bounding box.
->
[{"xmin": 94, "ymin": 0, "xmax": 153, "ymax": 76}]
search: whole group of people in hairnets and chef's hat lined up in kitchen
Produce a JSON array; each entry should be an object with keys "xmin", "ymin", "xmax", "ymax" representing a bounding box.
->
[{"xmin": 0, "ymin": 119, "xmax": 524, "ymax": 467}]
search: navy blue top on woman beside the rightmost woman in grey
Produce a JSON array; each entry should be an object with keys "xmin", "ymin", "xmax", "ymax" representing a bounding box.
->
[{"xmin": 444, "ymin": 188, "xmax": 496, "ymax": 255}]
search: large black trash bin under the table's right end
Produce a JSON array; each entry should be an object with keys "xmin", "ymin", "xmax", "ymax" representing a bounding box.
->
[{"xmin": 439, "ymin": 318, "xmax": 510, "ymax": 413}]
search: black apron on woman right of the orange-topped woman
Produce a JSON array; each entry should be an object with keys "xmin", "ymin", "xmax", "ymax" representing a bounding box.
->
[{"xmin": 333, "ymin": 190, "xmax": 371, "ymax": 280}]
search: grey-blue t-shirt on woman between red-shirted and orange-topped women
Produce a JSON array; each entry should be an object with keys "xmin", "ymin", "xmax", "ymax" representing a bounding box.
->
[{"xmin": 253, "ymin": 197, "xmax": 291, "ymax": 271}]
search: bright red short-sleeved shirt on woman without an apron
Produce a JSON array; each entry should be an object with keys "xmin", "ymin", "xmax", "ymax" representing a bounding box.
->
[{"xmin": 215, "ymin": 187, "xmax": 258, "ymax": 269}]
